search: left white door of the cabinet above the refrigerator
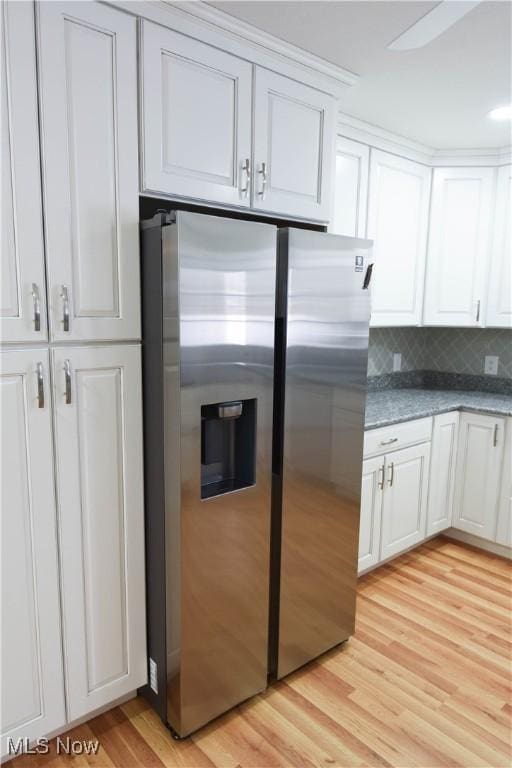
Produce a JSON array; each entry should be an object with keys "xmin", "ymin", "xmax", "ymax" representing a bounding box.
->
[{"xmin": 142, "ymin": 21, "xmax": 252, "ymax": 206}]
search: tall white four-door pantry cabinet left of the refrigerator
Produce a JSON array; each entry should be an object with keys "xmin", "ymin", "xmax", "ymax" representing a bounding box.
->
[{"xmin": 0, "ymin": 2, "xmax": 146, "ymax": 754}]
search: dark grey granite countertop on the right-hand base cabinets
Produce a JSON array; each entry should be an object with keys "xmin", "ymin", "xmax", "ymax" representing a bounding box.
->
[{"xmin": 365, "ymin": 388, "xmax": 512, "ymax": 429}]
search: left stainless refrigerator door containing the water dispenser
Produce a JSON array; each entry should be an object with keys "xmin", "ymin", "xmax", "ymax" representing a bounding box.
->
[{"xmin": 162, "ymin": 211, "xmax": 277, "ymax": 736}]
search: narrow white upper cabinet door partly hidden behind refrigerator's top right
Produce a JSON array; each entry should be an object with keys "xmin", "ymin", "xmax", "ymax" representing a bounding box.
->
[{"xmin": 329, "ymin": 136, "xmax": 370, "ymax": 237}]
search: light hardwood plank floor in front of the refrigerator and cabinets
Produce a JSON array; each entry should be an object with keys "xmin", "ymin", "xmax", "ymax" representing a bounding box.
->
[{"xmin": 11, "ymin": 537, "xmax": 512, "ymax": 768}]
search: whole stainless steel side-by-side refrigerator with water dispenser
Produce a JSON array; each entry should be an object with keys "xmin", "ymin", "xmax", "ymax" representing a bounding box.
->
[{"xmin": 141, "ymin": 211, "xmax": 371, "ymax": 736}]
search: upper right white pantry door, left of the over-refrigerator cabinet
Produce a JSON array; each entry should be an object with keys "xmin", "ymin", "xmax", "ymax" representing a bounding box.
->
[{"xmin": 37, "ymin": 2, "xmax": 140, "ymax": 341}]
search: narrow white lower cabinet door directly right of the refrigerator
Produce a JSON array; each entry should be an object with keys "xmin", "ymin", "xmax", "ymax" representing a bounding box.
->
[{"xmin": 358, "ymin": 456, "xmax": 385, "ymax": 572}]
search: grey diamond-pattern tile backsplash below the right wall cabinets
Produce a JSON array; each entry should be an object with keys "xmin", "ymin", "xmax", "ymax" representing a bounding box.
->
[{"xmin": 368, "ymin": 328, "xmax": 512, "ymax": 379}]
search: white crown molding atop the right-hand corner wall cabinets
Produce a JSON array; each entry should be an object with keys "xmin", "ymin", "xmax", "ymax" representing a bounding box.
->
[{"xmin": 338, "ymin": 112, "xmax": 512, "ymax": 167}]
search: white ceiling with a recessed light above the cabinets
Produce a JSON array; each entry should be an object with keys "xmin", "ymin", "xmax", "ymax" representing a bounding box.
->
[{"xmin": 209, "ymin": 0, "xmax": 512, "ymax": 149}]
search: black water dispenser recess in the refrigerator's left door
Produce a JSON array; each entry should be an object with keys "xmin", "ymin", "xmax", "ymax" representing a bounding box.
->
[{"xmin": 201, "ymin": 399, "xmax": 256, "ymax": 499}]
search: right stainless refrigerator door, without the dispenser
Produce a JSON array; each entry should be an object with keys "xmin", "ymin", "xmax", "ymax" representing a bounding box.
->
[{"xmin": 276, "ymin": 229, "xmax": 372, "ymax": 677}]
